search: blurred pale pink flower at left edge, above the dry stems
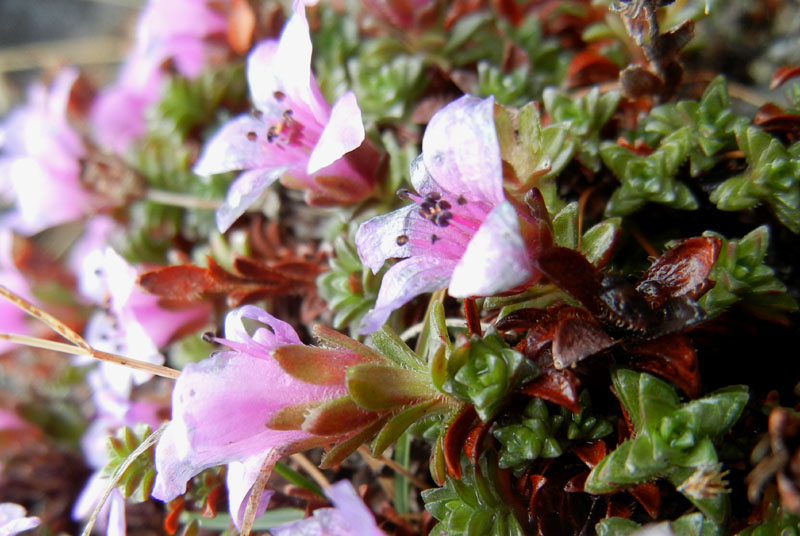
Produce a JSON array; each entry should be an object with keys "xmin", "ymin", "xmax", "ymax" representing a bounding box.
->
[{"xmin": 0, "ymin": 69, "xmax": 99, "ymax": 234}]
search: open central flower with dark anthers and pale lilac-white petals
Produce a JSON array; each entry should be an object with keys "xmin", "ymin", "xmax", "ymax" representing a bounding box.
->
[{"xmin": 356, "ymin": 95, "xmax": 538, "ymax": 334}]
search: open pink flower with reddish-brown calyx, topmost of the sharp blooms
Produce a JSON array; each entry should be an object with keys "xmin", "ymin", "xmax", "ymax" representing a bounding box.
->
[{"xmin": 194, "ymin": 0, "xmax": 373, "ymax": 231}]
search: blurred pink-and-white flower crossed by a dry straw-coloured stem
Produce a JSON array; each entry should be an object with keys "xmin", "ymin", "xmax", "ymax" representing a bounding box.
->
[{"xmin": 79, "ymin": 246, "xmax": 209, "ymax": 398}]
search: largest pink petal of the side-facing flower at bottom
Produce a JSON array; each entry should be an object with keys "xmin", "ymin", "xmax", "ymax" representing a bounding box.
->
[{"xmin": 153, "ymin": 352, "xmax": 346, "ymax": 501}]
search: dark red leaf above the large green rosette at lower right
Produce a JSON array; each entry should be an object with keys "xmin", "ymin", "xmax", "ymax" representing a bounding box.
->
[{"xmin": 628, "ymin": 334, "xmax": 700, "ymax": 398}]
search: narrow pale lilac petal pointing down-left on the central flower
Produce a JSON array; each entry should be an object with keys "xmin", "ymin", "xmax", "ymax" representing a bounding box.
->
[{"xmin": 358, "ymin": 253, "xmax": 456, "ymax": 335}]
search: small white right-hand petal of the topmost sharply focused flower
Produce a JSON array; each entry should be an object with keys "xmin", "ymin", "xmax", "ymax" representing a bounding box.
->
[{"xmin": 306, "ymin": 91, "xmax": 364, "ymax": 175}]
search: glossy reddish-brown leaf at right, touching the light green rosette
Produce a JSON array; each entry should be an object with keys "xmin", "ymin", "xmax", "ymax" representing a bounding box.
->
[{"xmin": 636, "ymin": 237, "xmax": 722, "ymax": 308}]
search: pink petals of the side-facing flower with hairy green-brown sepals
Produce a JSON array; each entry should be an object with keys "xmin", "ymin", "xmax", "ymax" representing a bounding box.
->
[{"xmin": 153, "ymin": 306, "xmax": 363, "ymax": 526}]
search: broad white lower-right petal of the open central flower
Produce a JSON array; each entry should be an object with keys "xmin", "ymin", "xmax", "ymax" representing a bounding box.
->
[{"xmin": 448, "ymin": 201, "xmax": 534, "ymax": 298}]
